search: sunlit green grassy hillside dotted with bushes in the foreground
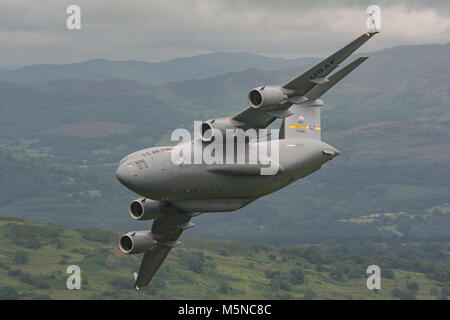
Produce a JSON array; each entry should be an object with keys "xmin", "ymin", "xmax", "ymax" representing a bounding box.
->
[{"xmin": 0, "ymin": 218, "xmax": 450, "ymax": 299}]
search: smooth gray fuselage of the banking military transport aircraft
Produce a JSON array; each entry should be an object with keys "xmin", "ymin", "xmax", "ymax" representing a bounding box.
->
[{"xmin": 117, "ymin": 139, "xmax": 339, "ymax": 202}]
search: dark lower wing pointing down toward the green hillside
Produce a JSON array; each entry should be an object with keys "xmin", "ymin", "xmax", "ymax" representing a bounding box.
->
[{"xmin": 135, "ymin": 208, "xmax": 194, "ymax": 289}]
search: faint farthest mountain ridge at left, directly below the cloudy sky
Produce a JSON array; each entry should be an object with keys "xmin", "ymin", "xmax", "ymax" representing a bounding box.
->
[{"xmin": 0, "ymin": 52, "xmax": 316, "ymax": 86}]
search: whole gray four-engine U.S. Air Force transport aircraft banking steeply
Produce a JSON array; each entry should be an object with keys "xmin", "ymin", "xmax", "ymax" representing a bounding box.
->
[{"xmin": 116, "ymin": 32, "xmax": 378, "ymax": 289}]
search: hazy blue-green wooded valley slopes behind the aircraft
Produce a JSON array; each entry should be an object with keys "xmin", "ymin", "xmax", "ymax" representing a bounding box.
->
[{"xmin": 0, "ymin": 41, "xmax": 450, "ymax": 244}]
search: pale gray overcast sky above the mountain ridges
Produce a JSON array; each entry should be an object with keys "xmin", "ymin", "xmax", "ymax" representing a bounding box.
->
[{"xmin": 0, "ymin": 0, "xmax": 450, "ymax": 65}]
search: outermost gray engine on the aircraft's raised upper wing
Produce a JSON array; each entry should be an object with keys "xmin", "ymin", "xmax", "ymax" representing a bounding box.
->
[{"xmin": 248, "ymin": 86, "xmax": 288, "ymax": 109}]
